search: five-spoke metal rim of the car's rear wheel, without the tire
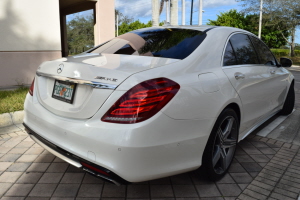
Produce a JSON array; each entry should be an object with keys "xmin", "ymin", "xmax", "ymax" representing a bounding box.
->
[{"xmin": 212, "ymin": 116, "xmax": 238, "ymax": 174}]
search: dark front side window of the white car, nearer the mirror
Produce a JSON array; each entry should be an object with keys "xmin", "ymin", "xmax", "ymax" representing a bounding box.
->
[{"xmin": 251, "ymin": 36, "xmax": 276, "ymax": 65}]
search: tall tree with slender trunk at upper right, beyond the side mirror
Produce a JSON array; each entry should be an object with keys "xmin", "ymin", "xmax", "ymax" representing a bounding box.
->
[{"xmin": 239, "ymin": 0, "xmax": 300, "ymax": 57}]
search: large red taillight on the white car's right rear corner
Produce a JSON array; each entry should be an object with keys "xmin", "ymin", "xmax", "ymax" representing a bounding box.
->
[{"xmin": 101, "ymin": 78, "xmax": 180, "ymax": 124}]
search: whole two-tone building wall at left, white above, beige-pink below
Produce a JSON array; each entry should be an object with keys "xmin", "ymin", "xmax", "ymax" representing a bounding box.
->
[{"xmin": 0, "ymin": 0, "xmax": 61, "ymax": 87}]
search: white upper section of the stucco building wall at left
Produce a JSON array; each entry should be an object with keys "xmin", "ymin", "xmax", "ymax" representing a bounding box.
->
[{"xmin": 0, "ymin": 0, "xmax": 61, "ymax": 52}]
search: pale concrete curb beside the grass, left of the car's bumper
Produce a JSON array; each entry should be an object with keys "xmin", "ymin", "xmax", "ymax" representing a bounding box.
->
[{"xmin": 0, "ymin": 110, "xmax": 24, "ymax": 128}]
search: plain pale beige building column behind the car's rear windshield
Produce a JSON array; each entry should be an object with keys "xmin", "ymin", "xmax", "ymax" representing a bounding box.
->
[{"xmin": 94, "ymin": 0, "xmax": 115, "ymax": 46}]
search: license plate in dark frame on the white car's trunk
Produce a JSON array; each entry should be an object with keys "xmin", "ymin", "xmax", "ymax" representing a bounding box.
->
[{"xmin": 52, "ymin": 80, "xmax": 76, "ymax": 104}]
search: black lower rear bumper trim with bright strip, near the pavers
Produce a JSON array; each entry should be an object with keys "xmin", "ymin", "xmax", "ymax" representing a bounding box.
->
[{"xmin": 23, "ymin": 123, "xmax": 129, "ymax": 185}]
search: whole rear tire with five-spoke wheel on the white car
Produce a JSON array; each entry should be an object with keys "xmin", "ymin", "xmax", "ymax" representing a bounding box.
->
[{"xmin": 196, "ymin": 108, "xmax": 239, "ymax": 181}]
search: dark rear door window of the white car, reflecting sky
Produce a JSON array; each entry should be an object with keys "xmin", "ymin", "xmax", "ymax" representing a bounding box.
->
[{"xmin": 230, "ymin": 34, "xmax": 259, "ymax": 65}]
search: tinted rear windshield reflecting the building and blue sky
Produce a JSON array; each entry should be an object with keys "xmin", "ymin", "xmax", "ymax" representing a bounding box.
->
[{"xmin": 89, "ymin": 28, "xmax": 206, "ymax": 59}]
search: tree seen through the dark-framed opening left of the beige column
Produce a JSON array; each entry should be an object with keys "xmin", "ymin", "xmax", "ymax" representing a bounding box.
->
[{"xmin": 67, "ymin": 16, "xmax": 94, "ymax": 53}]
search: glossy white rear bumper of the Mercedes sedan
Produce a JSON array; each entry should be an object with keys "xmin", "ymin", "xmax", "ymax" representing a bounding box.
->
[{"xmin": 24, "ymin": 95, "xmax": 215, "ymax": 182}]
